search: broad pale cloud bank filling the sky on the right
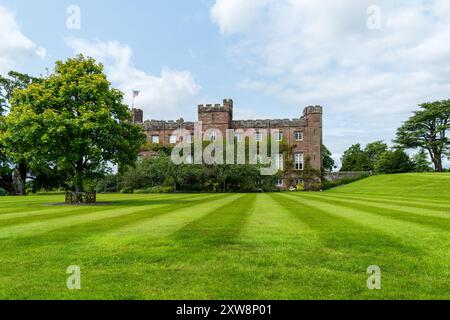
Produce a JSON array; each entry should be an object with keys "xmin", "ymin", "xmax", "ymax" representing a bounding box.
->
[{"xmin": 211, "ymin": 0, "xmax": 450, "ymax": 162}]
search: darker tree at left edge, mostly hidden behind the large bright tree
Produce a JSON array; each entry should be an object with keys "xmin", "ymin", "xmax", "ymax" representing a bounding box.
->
[{"xmin": 0, "ymin": 71, "xmax": 41, "ymax": 195}]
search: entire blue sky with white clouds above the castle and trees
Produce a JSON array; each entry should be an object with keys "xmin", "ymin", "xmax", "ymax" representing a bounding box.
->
[{"xmin": 0, "ymin": 0, "xmax": 450, "ymax": 165}]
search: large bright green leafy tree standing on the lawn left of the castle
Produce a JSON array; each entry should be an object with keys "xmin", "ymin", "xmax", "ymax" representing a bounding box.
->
[{"xmin": 1, "ymin": 55, "xmax": 145, "ymax": 191}]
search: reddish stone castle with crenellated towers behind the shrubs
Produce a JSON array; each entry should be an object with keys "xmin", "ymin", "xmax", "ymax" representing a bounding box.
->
[{"xmin": 131, "ymin": 99, "xmax": 323, "ymax": 187}]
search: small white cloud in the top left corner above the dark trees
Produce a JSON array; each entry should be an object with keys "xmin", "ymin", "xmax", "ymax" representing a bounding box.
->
[{"xmin": 0, "ymin": 6, "xmax": 46, "ymax": 74}]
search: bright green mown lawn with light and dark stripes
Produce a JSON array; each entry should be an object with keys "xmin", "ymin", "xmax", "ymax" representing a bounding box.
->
[{"xmin": 0, "ymin": 174, "xmax": 450, "ymax": 299}]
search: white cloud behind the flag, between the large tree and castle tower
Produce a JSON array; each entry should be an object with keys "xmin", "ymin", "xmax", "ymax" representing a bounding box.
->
[{"xmin": 66, "ymin": 38, "xmax": 200, "ymax": 119}]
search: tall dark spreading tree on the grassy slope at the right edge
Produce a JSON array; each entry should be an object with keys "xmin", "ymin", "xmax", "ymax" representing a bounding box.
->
[{"xmin": 395, "ymin": 100, "xmax": 450, "ymax": 172}]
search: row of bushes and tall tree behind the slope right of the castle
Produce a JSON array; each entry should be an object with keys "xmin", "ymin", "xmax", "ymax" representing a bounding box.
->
[{"xmin": 341, "ymin": 100, "xmax": 450, "ymax": 174}]
